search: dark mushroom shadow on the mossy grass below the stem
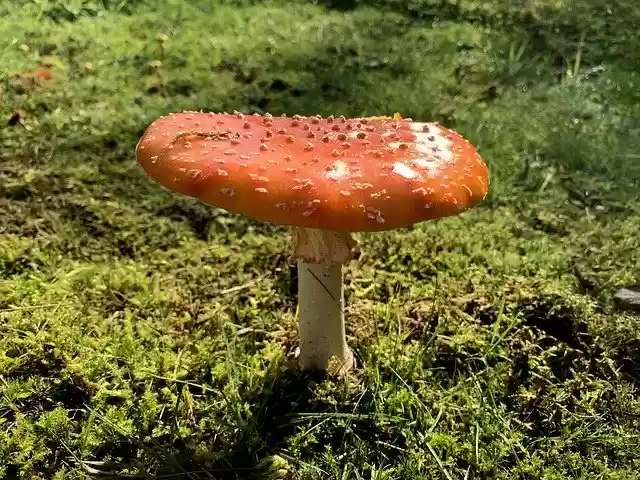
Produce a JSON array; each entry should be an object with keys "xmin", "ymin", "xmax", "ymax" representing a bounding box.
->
[{"xmin": 79, "ymin": 370, "xmax": 404, "ymax": 480}]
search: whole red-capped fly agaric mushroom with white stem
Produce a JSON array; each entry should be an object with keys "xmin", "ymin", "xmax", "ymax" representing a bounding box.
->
[{"xmin": 136, "ymin": 112, "xmax": 489, "ymax": 372}]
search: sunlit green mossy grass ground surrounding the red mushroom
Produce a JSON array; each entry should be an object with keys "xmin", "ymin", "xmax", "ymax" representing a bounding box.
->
[{"xmin": 0, "ymin": 0, "xmax": 640, "ymax": 480}]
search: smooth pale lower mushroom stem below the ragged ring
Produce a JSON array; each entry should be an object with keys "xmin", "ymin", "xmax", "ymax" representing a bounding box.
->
[{"xmin": 298, "ymin": 260, "xmax": 354, "ymax": 373}]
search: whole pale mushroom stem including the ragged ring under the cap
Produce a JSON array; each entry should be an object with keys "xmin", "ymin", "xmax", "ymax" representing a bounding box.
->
[{"xmin": 294, "ymin": 228, "xmax": 355, "ymax": 373}]
